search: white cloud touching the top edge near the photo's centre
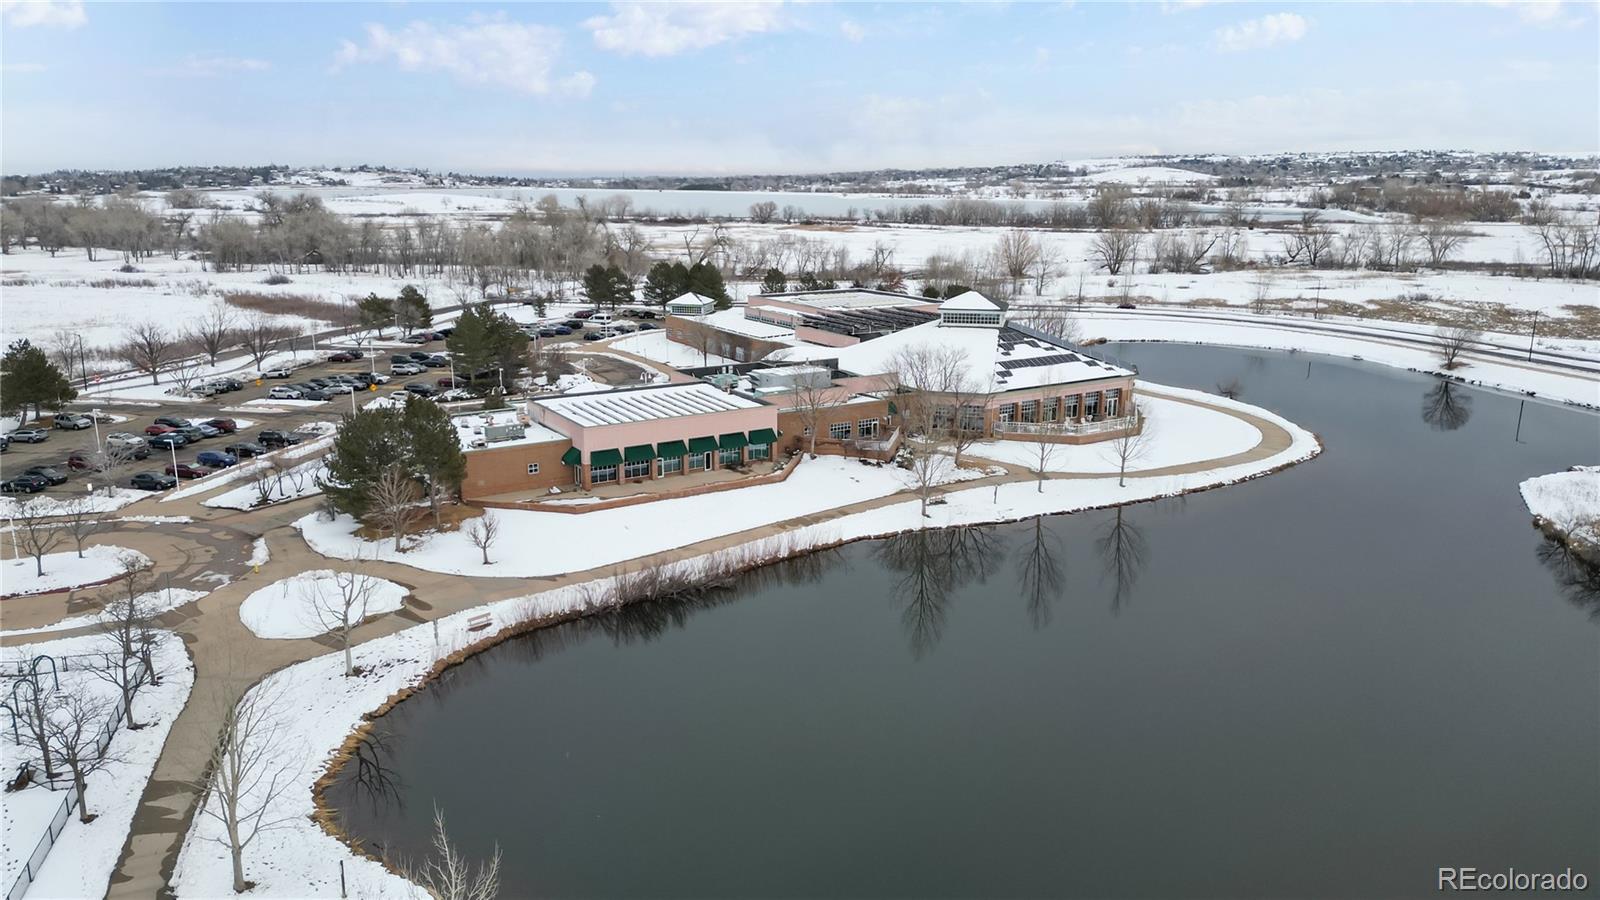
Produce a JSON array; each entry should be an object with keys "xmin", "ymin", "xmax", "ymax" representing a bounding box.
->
[{"xmin": 584, "ymin": 0, "xmax": 784, "ymax": 56}]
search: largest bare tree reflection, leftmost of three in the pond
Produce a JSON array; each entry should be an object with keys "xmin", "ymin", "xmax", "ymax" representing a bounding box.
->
[{"xmin": 877, "ymin": 525, "xmax": 1005, "ymax": 660}]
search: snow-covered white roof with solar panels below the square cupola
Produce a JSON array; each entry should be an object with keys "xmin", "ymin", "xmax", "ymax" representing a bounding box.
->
[{"xmin": 835, "ymin": 320, "xmax": 1133, "ymax": 392}]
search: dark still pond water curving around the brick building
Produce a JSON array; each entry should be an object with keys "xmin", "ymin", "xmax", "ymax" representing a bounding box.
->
[{"xmin": 331, "ymin": 346, "xmax": 1600, "ymax": 897}]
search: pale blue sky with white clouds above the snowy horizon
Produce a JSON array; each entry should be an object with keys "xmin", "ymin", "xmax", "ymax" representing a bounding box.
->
[{"xmin": 0, "ymin": 0, "xmax": 1600, "ymax": 175}]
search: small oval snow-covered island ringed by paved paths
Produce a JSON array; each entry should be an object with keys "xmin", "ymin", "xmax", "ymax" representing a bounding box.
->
[{"xmin": 238, "ymin": 569, "xmax": 406, "ymax": 637}]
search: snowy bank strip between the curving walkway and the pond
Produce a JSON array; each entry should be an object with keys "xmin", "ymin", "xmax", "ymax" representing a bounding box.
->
[{"xmin": 173, "ymin": 389, "xmax": 1322, "ymax": 897}]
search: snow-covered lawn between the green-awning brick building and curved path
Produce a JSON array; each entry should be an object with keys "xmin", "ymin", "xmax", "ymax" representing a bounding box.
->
[{"xmin": 294, "ymin": 456, "xmax": 984, "ymax": 578}]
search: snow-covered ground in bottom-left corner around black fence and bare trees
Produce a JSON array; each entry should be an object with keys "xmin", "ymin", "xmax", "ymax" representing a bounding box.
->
[{"xmin": 0, "ymin": 633, "xmax": 194, "ymax": 897}]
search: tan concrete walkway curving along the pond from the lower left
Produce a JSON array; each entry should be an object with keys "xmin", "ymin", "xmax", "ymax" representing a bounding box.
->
[{"xmin": 0, "ymin": 384, "xmax": 1293, "ymax": 900}]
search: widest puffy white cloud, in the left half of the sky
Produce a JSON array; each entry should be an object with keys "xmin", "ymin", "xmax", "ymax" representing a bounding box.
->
[{"xmin": 334, "ymin": 16, "xmax": 595, "ymax": 96}]
